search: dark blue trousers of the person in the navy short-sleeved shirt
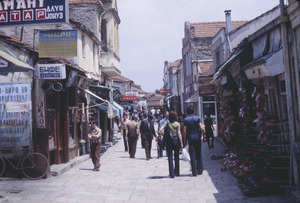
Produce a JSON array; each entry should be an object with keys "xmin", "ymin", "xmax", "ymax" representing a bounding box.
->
[{"xmin": 188, "ymin": 139, "xmax": 203, "ymax": 176}]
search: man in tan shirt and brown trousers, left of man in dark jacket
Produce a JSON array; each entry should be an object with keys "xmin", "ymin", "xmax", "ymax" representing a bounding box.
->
[{"xmin": 126, "ymin": 116, "xmax": 139, "ymax": 158}]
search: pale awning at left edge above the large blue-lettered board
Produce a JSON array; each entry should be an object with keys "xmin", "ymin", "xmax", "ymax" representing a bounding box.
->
[{"xmin": 0, "ymin": 45, "xmax": 34, "ymax": 73}]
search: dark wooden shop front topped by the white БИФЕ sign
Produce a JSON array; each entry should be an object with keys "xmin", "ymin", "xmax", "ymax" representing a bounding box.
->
[{"xmin": 35, "ymin": 64, "xmax": 86, "ymax": 165}]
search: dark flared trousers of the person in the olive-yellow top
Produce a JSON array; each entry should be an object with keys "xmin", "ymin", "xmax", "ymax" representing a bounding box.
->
[{"xmin": 166, "ymin": 143, "xmax": 180, "ymax": 178}]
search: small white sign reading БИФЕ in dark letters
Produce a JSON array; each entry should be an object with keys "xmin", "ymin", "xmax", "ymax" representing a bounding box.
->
[{"xmin": 37, "ymin": 64, "xmax": 66, "ymax": 80}]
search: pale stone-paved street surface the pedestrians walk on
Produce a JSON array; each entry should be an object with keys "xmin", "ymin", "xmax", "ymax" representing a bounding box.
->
[{"xmin": 0, "ymin": 124, "xmax": 290, "ymax": 203}]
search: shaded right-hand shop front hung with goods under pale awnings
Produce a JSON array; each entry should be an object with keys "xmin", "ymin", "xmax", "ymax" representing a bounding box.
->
[{"xmin": 214, "ymin": 29, "xmax": 293, "ymax": 194}]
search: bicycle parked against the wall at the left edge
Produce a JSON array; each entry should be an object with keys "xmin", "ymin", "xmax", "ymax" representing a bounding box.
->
[{"xmin": 0, "ymin": 146, "xmax": 49, "ymax": 180}]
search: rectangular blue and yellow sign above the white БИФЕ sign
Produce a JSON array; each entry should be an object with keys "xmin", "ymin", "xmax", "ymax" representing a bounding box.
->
[{"xmin": 39, "ymin": 30, "xmax": 77, "ymax": 58}]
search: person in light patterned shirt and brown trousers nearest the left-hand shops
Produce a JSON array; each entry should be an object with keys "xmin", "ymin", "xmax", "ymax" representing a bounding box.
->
[{"xmin": 88, "ymin": 121, "xmax": 102, "ymax": 171}]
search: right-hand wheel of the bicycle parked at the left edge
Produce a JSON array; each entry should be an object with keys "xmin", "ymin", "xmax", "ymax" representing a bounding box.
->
[{"xmin": 21, "ymin": 152, "xmax": 49, "ymax": 180}]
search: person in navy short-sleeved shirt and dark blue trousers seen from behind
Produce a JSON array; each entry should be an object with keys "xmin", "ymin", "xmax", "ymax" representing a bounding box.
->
[{"xmin": 184, "ymin": 107, "xmax": 205, "ymax": 176}]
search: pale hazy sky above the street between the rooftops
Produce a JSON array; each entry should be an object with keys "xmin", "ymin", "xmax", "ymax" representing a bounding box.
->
[{"xmin": 117, "ymin": 0, "xmax": 279, "ymax": 92}]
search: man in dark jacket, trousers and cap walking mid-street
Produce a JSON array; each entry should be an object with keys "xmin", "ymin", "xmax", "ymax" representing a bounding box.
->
[{"xmin": 140, "ymin": 114, "xmax": 156, "ymax": 161}]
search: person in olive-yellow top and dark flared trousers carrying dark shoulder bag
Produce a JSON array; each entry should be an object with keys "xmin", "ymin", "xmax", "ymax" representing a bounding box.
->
[{"xmin": 159, "ymin": 111, "xmax": 183, "ymax": 178}]
